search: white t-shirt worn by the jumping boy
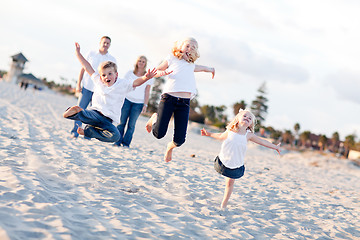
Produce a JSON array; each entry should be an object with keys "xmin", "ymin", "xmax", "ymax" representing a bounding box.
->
[{"xmin": 90, "ymin": 73, "xmax": 134, "ymax": 126}]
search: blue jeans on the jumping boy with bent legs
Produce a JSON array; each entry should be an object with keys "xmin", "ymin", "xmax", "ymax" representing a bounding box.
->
[{"xmin": 67, "ymin": 110, "xmax": 120, "ymax": 142}]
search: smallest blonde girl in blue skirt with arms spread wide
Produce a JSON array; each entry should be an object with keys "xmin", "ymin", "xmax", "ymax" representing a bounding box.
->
[{"xmin": 201, "ymin": 109, "xmax": 281, "ymax": 208}]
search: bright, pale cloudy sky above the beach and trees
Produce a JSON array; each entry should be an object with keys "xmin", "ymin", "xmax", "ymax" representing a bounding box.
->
[{"xmin": 0, "ymin": 0, "xmax": 360, "ymax": 141}]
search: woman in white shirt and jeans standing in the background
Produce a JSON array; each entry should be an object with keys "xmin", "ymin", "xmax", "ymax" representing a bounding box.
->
[{"xmin": 115, "ymin": 56, "xmax": 152, "ymax": 147}]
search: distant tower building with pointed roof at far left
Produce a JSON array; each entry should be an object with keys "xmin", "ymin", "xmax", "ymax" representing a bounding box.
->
[{"xmin": 5, "ymin": 53, "xmax": 44, "ymax": 89}]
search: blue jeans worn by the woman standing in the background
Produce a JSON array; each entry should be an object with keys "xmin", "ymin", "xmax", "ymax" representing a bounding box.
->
[{"xmin": 115, "ymin": 98, "xmax": 144, "ymax": 147}]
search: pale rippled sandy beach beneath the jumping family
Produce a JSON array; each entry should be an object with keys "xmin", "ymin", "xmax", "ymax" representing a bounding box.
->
[{"xmin": 0, "ymin": 82, "xmax": 360, "ymax": 240}]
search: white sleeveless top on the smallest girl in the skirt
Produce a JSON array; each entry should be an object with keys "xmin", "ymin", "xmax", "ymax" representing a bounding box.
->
[{"xmin": 219, "ymin": 130, "xmax": 249, "ymax": 169}]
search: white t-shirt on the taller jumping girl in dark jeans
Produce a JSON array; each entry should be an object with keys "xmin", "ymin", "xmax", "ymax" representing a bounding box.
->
[{"xmin": 163, "ymin": 55, "xmax": 196, "ymax": 98}]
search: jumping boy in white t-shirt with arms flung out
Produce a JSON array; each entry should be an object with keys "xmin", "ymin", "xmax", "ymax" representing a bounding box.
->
[{"xmin": 63, "ymin": 43, "xmax": 169, "ymax": 142}]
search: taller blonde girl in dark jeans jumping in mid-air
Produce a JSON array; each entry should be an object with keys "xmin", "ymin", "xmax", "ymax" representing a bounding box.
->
[{"xmin": 146, "ymin": 38, "xmax": 215, "ymax": 162}]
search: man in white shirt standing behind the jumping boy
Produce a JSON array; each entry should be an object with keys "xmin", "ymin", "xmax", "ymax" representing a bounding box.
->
[{"xmin": 71, "ymin": 36, "xmax": 116, "ymax": 139}]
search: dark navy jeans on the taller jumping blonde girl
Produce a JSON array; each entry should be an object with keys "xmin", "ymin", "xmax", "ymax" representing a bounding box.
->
[{"xmin": 153, "ymin": 93, "xmax": 190, "ymax": 147}]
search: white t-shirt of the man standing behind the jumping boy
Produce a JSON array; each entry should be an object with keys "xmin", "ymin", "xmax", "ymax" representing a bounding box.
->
[{"xmin": 82, "ymin": 51, "xmax": 116, "ymax": 92}]
